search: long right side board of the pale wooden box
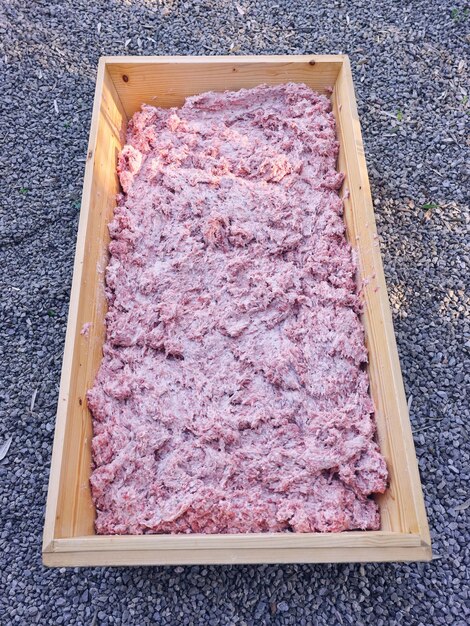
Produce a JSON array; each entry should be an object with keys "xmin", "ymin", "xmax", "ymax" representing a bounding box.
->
[{"xmin": 333, "ymin": 60, "xmax": 430, "ymax": 543}]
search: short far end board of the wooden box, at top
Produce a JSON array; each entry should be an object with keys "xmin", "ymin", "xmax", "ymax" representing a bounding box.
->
[{"xmin": 108, "ymin": 56, "xmax": 343, "ymax": 117}]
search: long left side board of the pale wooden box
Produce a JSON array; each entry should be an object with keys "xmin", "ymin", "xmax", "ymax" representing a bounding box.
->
[{"xmin": 47, "ymin": 64, "xmax": 127, "ymax": 537}]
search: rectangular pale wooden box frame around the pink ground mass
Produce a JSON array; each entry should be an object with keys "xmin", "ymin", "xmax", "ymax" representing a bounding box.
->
[{"xmin": 43, "ymin": 55, "xmax": 431, "ymax": 566}]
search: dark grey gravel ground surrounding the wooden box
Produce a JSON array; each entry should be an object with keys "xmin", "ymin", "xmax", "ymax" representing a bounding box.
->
[{"xmin": 0, "ymin": 0, "xmax": 470, "ymax": 626}]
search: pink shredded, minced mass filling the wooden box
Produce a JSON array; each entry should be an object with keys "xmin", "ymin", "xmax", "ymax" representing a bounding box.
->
[{"xmin": 88, "ymin": 83, "xmax": 387, "ymax": 534}]
